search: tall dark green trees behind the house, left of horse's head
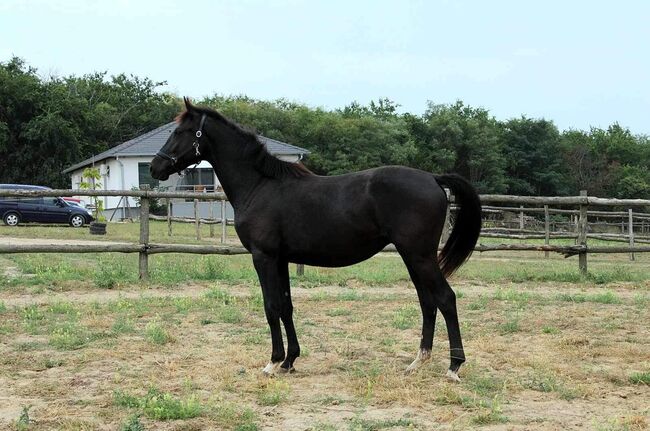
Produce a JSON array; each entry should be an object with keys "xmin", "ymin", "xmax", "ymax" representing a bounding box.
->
[{"xmin": 0, "ymin": 57, "xmax": 180, "ymax": 187}]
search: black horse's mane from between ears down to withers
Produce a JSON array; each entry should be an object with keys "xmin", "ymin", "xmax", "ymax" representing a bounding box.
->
[{"xmin": 176, "ymin": 106, "xmax": 314, "ymax": 179}]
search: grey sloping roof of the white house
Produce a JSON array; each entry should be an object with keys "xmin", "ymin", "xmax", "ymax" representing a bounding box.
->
[{"xmin": 63, "ymin": 122, "xmax": 309, "ymax": 174}]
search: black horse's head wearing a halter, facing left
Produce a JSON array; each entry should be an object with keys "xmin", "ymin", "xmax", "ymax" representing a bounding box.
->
[{"xmin": 150, "ymin": 98, "xmax": 207, "ymax": 181}]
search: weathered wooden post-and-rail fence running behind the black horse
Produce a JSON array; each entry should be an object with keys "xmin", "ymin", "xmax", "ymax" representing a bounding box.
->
[{"xmin": 0, "ymin": 190, "xmax": 650, "ymax": 279}]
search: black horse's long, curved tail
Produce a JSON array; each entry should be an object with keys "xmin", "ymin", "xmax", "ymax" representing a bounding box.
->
[{"xmin": 436, "ymin": 174, "xmax": 481, "ymax": 277}]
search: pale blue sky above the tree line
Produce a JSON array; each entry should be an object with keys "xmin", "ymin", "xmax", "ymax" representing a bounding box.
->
[{"xmin": 0, "ymin": 0, "xmax": 650, "ymax": 135}]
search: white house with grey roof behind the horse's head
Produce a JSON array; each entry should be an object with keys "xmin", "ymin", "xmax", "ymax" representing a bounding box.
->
[{"xmin": 63, "ymin": 122, "xmax": 309, "ymax": 220}]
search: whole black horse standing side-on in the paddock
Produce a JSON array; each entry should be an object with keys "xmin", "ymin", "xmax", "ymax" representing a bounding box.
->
[{"xmin": 151, "ymin": 99, "xmax": 481, "ymax": 380}]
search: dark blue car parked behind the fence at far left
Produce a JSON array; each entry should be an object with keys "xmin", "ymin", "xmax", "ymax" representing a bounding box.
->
[{"xmin": 0, "ymin": 184, "xmax": 93, "ymax": 227}]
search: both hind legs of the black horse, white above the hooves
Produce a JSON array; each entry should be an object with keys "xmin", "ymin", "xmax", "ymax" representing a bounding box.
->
[{"xmin": 401, "ymin": 253, "xmax": 465, "ymax": 381}]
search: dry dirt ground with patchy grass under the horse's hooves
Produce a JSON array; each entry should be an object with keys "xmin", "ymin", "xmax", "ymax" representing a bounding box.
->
[{"xmin": 0, "ymin": 264, "xmax": 650, "ymax": 431}]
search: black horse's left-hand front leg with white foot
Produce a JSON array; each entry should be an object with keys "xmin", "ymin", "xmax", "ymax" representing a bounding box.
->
[{"xmin": 253, "ymin": 252, "xmax": 292, "ymax": 375}]
